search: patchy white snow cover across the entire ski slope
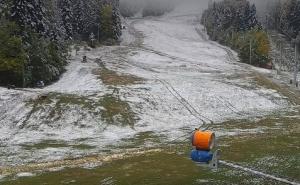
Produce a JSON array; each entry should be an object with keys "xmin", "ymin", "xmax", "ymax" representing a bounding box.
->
[{"xmin": 0, "ymin": 5, "xmax": 288, "ymax": 168}]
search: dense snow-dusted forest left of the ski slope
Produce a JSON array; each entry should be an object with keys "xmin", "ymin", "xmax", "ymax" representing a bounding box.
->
[{"xmin": 0, "ymin": 0, "xmax": 121, "ymax": 87}]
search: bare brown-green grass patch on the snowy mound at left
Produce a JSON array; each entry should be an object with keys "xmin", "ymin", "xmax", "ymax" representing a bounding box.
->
[{"xmin": 23, "ymin": 93, "xmax": 138, "ymax": 127}]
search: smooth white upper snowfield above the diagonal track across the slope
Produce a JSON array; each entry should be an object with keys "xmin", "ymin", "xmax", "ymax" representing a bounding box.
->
[{"xmin": 136, "ymin": 17, "xmax": 238, "ymax": 72}]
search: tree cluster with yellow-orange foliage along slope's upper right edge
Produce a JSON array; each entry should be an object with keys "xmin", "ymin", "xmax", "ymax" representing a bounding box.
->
[{"xmin": 201, "ymin": 0, "xmax": 270, "ymax": 67}]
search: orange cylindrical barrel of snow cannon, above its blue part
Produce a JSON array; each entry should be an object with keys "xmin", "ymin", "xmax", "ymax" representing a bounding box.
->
[{"xmin": 192, "ymin": 129, "xmax": 215, "ymax": 151}]
